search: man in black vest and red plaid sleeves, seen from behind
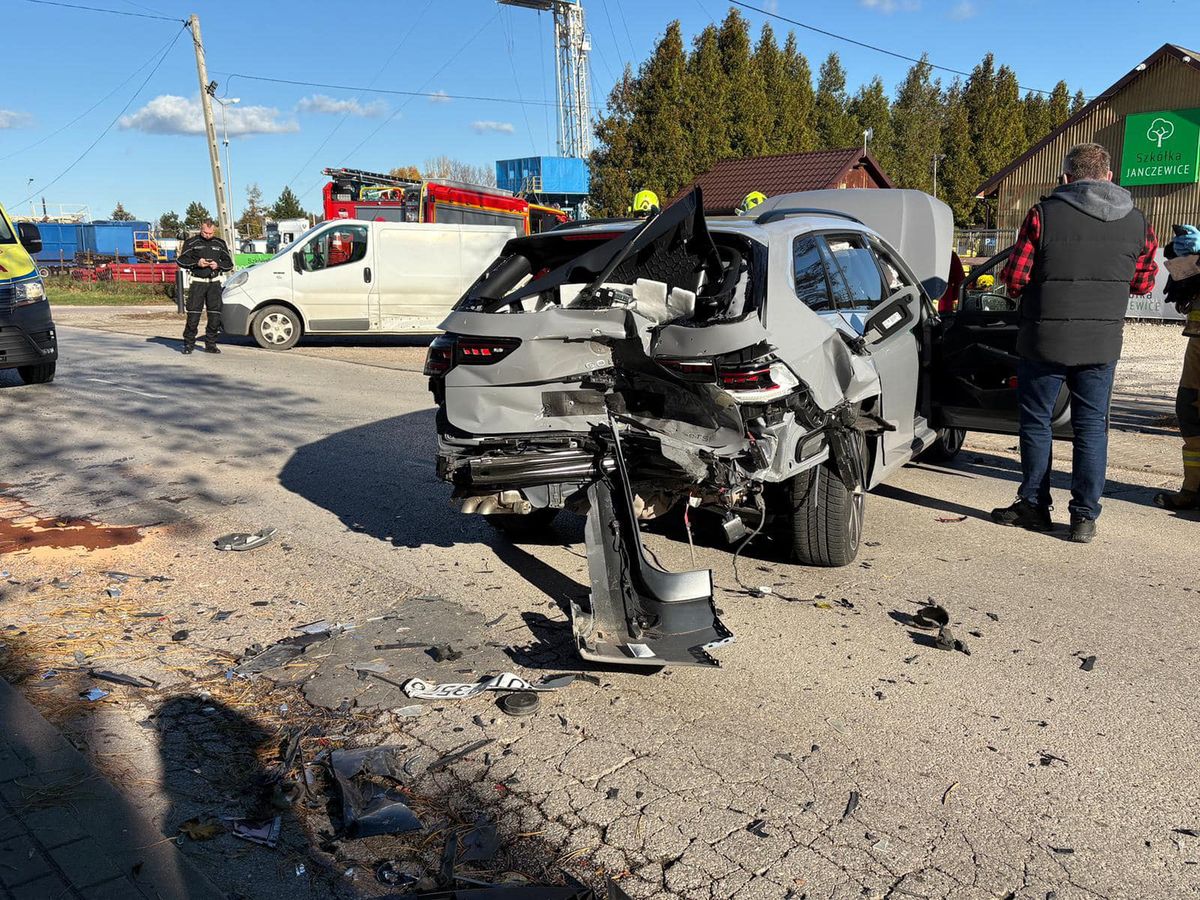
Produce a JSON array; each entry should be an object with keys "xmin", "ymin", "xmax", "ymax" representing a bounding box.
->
[{"xmin": 991, "ymin": 144, "xmax": 1158, "ymax": 544}]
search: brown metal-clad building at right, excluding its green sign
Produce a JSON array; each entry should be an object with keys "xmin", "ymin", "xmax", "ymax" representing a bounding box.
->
[{"xmin": 978, "ymin": 44, "xmax": 1200, "ymax": 239}]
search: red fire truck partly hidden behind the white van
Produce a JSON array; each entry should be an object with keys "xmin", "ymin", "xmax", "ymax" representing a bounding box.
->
[{"xmin": 324, "ymin": 169, "xmax": 568, "ymax": 234}]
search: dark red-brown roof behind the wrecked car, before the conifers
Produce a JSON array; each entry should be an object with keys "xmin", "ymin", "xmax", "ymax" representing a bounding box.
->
[{"xmin": 679, "ymin": 146, "xmax": 893, "ymax": 211}]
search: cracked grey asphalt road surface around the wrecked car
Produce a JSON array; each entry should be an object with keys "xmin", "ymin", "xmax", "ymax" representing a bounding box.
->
[{"xmin": 0, "ymin": 326, "xmax": 1200, "ymax": 900}]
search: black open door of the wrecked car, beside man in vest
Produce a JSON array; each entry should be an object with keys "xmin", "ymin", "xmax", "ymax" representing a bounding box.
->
[{"xmin": 932, "ymin": 247, "xmax": 1072, "ymax": 438}]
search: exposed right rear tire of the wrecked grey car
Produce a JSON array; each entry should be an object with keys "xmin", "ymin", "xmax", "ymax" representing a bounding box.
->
[{"xmin": 786, "ymin": 461, "xmax": 866, "ymax": 566}]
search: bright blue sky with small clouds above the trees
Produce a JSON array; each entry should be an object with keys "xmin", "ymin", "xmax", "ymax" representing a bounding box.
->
[{"xmin": 0, "ymin": 0, "xmax": 1187, "ymax": 225}]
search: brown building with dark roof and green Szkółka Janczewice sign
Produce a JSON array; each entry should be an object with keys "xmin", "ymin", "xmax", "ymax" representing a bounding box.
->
[{"xmin": 978, "ymin": 43, "xmax": 1200, "ymax": 240}]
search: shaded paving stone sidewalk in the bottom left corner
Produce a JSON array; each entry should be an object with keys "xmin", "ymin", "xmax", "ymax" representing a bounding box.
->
[{"xmin": 0, "ymin": 679, "xmax": 224, "ymax": 900}]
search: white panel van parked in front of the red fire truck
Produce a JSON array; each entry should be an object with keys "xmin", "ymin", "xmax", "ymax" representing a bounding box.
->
[{"xmin": 222, "ymin": 218, "xmax": 516, "ymax": 350}]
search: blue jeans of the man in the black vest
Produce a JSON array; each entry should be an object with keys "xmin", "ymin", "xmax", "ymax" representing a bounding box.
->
[{"xmin": 1016, "ymin": 359, "xmax": 1117, "ymax": 518}]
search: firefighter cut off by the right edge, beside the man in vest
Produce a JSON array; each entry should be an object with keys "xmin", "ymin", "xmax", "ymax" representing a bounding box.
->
[{"xmin": 1154, "ymin": 226, "xmax": 1200, "ymax": 510}]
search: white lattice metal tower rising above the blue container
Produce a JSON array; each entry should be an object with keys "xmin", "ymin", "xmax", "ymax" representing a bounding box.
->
[{"xmin": 497, "ymin": 0, "xmax": 592, "ymax": 160}]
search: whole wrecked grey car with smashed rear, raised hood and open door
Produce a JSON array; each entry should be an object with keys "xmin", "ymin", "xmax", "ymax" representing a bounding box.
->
[{"xmin": 426, "ymin": 190, "xmax": 1032, "ymax": 666}]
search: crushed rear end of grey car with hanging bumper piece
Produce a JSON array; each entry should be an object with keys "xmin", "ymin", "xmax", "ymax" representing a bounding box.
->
[{"xmin": 426, "ymin": 191, "xmax": 892, "ymax": 666}]
